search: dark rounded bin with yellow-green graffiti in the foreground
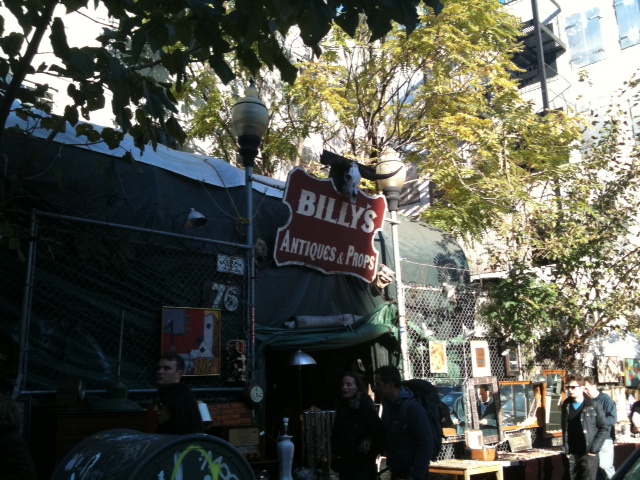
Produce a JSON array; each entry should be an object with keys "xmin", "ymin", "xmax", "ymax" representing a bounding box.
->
[{"xmin": 51, "ymin": 429, "xmax": 255, "ymax": 480}]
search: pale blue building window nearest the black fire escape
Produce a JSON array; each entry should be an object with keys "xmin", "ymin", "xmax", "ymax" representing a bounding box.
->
[{"xmin": 565, "ymin": 8, "xmax": 605, "ymax": 68}]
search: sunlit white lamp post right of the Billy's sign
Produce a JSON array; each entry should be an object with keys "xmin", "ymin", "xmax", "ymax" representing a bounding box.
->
[{"xmin": 376, "ymin": 147, "xmax": 411, "ymax": 379}]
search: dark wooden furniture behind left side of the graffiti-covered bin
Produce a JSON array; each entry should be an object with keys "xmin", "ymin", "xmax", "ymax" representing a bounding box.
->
[{"xmin": 29, "ymin": 408, "xmax": 146, "ymax": 478}]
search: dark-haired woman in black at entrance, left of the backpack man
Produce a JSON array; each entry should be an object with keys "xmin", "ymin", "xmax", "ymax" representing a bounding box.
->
[{"xmin": 331, "ymin": 372, "xmax": 384, "ymax": 480}]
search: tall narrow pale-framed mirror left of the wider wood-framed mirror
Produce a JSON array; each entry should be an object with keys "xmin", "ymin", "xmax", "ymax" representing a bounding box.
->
[{"xmin": 467, "ymin": 377, "xmax": 504, "ymax": 444}]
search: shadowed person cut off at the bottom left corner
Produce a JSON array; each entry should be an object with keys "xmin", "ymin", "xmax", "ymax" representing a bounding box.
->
[{"xmin": 0, "ymin": 397, "xmax": 38, "ymax": 480}]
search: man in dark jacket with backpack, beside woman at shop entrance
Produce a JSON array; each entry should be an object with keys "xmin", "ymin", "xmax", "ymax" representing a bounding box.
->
[{"xmin": 373, "ymin": 365, "xmax": 435, "ymax": 480}]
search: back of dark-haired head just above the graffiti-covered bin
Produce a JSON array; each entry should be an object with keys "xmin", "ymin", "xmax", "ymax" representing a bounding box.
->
[{"xmin": 153, "ymin": 383, "xmax": 203, "ymax": 435}]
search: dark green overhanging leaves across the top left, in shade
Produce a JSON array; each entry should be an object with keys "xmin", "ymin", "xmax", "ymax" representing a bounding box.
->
[{"xmin": 0, "ymin": 0, "xmax": 448, "ymax": 158}]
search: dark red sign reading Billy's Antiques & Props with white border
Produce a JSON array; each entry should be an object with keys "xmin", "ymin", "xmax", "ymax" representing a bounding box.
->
[{"xmin": 274, "ymin": 168, "xmax": 387, "ymax": 282}]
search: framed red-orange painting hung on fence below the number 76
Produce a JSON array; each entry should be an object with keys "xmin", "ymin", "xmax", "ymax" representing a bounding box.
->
[{"xmin": 161, "ymin": 307, "xmax": 222, "ymax": 376}]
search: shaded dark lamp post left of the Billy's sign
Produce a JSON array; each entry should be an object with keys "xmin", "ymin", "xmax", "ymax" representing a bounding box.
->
[{"xmin": 231, "ymin": 82, "xmax": 269, "ymax": 378}]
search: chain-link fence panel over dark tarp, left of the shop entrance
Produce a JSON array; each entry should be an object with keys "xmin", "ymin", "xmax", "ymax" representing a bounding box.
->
[{"xmin": 15, "ymin": 215, "xmax": 247, "ymax": 393}]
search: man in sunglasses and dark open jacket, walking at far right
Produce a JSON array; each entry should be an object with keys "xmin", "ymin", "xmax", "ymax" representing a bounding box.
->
[{"xmin": 562, "ymin": 375, "xmax": 609, "ymax": 480}]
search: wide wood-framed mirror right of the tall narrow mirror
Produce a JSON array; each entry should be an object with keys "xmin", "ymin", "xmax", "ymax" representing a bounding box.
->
[{"xmin": 499, "ymin": 381, "xmax": 542, "ymax": 431}]
